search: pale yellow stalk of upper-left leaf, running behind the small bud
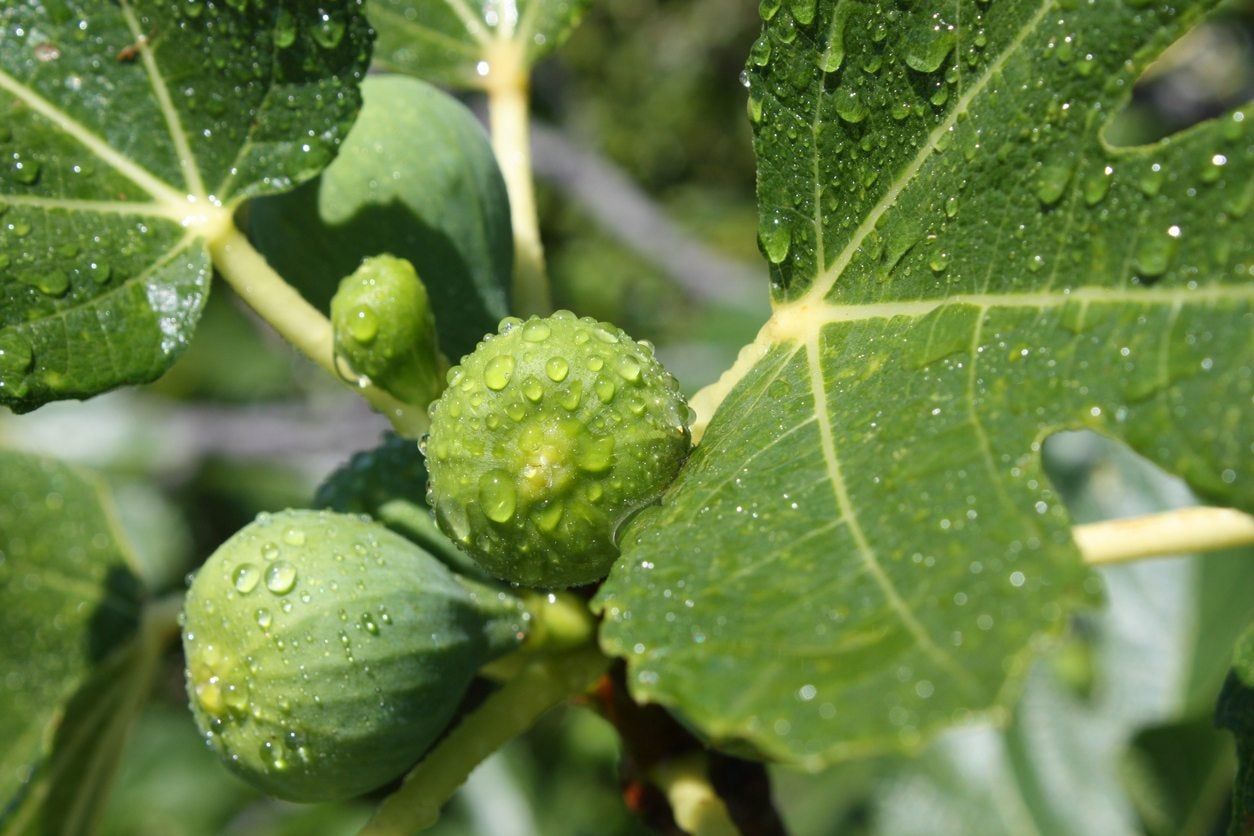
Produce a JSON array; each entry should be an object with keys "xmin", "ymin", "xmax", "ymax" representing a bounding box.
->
[{"xmin": 208, "ymin": 223, "xmax": 429, "ymax": 439}]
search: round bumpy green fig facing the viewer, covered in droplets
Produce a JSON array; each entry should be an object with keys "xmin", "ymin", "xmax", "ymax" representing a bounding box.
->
[{"xmin": 425, "ymin": 311, "xmax": 691, "ymax": 588}]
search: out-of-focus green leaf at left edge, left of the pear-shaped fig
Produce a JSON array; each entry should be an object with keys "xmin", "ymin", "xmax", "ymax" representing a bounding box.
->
[{"xmin": 0, "ymin": 451, "xmax": 143, "ymax": 832}]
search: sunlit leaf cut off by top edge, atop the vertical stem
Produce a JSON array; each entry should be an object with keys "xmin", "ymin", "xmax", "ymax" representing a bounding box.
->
[{"xmin": 367, "ymin": 0, "xmax": 591, "ymax": 88}]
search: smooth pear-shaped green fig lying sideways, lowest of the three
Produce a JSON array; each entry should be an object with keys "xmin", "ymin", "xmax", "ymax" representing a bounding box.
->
[{"xmin": 183, "ymin": 511, "xmax": 528, "ymax": 801}]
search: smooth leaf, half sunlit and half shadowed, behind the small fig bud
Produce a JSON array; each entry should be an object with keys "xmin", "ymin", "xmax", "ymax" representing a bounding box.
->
[{"xmin": 250, "ymin": 76, "xmax": 514, "ymax": 358}]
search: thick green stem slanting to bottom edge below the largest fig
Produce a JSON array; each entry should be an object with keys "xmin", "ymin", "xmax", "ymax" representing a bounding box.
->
[{"xmin": 361, "ymin": 647, "xmax": 609, "ymax": 836}]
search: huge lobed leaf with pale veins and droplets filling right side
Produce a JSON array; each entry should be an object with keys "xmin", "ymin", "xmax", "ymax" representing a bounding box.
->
[{"xmin": 598, "ymin": 0, "xmax": 1254, "ymax": 767}]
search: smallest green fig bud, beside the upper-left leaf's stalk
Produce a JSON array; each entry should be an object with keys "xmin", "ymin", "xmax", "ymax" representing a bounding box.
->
[{"xmin": 331, "ymin": 256, "xmax": 443, "ymax": 406}]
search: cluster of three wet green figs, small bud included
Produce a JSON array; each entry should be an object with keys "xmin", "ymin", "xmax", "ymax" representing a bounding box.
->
[{"xmin": 183, "ymin": 257, "xmax": 691, "ymax": 801}]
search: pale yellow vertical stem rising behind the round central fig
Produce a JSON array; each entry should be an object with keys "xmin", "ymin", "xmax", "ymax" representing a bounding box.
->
[{"xmin": 484, "ymin": 38, "xmax": 553, "ymax": 316}]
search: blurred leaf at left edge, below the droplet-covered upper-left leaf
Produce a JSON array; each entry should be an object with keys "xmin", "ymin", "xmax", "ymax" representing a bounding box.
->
[{"xmin": 0, "ymin": 451, "xmax": 140, "ymax": 830}]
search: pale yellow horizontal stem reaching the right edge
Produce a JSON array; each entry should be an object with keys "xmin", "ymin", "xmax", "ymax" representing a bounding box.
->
[{"xmin": 1071, "ymin": 508, "xmax": 1254, "ymax": 565}]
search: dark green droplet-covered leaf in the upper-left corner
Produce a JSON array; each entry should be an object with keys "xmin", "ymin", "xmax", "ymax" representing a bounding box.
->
[{"xmin": 0, "ymin": 0, "xmax": 370, "ymax": 411}]
